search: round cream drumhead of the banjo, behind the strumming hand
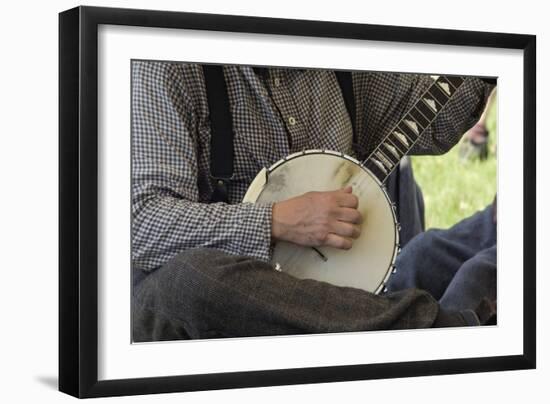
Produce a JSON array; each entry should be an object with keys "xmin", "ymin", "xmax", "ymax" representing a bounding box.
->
[{"xmin": 252, "ymin": 150, "xmax": 398, "ymax": 293}]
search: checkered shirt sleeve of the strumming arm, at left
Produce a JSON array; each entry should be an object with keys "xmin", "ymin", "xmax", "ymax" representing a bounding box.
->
[{"xmin": 132, "ymin": 61, "xmax": 272, "ymax": 271}]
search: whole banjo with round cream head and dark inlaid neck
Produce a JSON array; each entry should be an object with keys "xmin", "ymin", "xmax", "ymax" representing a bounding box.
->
[{"xmin": 243, "ymin": 76, "xmax": 464, "ymax": 293}]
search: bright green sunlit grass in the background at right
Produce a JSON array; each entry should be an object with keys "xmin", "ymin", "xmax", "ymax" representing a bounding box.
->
[{"xmin": 411, "ymin": 98, "xmax": 497, "ymax": 229}]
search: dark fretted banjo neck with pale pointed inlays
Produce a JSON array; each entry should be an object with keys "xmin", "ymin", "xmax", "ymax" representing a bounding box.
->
[{"xmin": 363, "ymin": 76, "xmax": 464, "ymax": 183}]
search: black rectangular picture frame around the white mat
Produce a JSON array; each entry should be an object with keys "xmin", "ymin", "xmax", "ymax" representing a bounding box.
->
[{"xmin": 59, "ymin": 7, "xmax": 536, "ymax": 398}]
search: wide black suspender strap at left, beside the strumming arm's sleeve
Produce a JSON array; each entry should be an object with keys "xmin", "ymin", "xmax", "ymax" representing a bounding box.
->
[{"xmin": 203, "ymin": 65, "xmax": 233, "ymax": 202}]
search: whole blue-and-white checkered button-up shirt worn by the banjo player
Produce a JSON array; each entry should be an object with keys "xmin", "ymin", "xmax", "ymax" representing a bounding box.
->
[{"xmin": 131, "ymin": 61, "xmax": 491, "ymax": 271}]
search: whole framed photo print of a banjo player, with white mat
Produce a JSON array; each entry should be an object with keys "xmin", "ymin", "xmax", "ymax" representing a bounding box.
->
[{"xmin": 59, "ymin": 7, "xmax": 536, "ymax": 397}]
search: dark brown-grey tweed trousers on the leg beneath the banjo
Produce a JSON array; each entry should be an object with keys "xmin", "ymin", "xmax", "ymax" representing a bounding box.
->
[{"xmin": 132, "ymin": 248, "xmax": 476, "ymax": 342}]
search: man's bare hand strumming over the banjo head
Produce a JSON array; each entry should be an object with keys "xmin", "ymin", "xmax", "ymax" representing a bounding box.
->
[{"xmin": 271, "ymin": 187, "xmax": 362, "ymax": 250}]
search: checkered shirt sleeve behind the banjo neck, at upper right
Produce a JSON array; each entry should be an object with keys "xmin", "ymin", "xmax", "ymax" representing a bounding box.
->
[{"xmin": 358, "ymin": 73, "xmax": 493, "ymax": 154}]
